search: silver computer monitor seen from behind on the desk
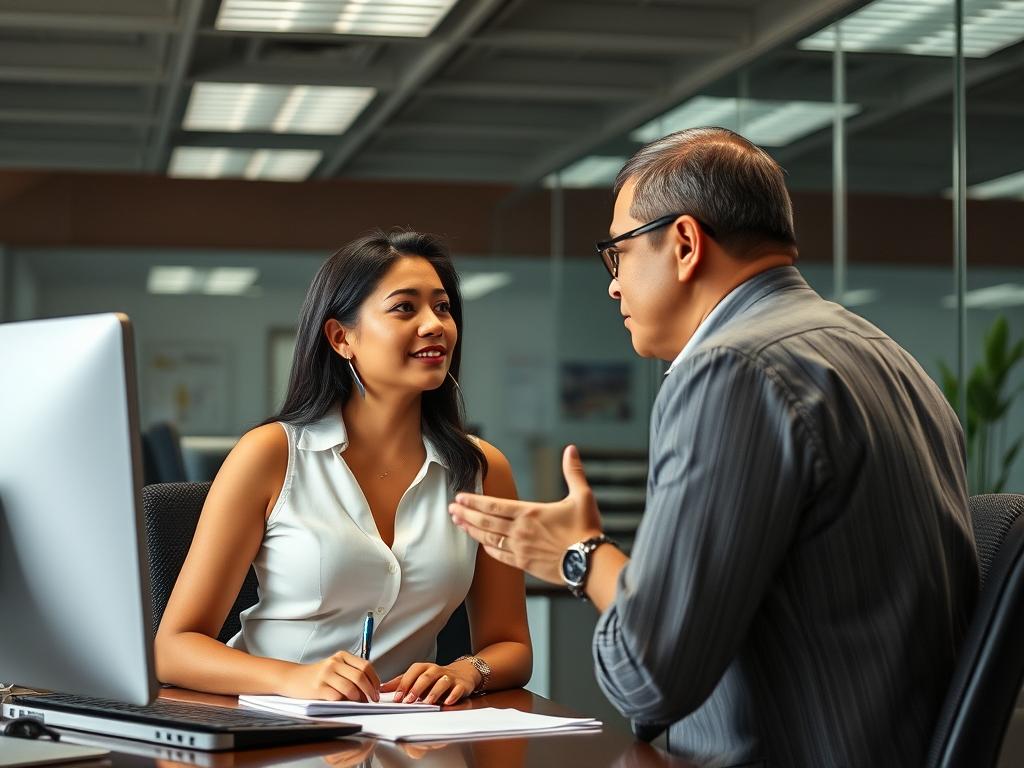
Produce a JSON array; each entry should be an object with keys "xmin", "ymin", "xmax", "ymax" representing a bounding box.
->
[{"xmin": 0, "ymin": 313, "xmax": 157, "ymax": 703}]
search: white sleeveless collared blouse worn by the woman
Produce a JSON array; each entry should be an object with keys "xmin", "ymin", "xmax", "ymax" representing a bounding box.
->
[{"xmin": 227, "ymin": 409, "xmax": 480, "ymax": 681}]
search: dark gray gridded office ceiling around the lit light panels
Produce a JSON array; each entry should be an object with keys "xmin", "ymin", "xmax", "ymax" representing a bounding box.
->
[{"xmin": 0, "ymin": 0, "xmax": 1024, "ymax": 194}]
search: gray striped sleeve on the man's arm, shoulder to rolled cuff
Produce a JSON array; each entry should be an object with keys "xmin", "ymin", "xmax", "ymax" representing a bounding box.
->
[{"xmin": 593, "ymin": 348, "xmax": 826, "ymax": 723}]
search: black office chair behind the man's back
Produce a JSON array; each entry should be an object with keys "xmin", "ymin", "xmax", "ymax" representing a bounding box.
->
[{"xmin": 928, "ymin": 494, "xmax": 1024, "ymax": 768}]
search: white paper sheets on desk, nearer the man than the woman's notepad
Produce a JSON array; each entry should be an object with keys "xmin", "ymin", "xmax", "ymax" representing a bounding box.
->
[{"xmin": 335, "ymin": 707, "xmax": 601, "ymax": 741}]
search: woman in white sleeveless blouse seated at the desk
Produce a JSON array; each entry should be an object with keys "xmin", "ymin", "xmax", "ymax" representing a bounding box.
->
[{"xmin": 156, "ymin": 231, "xmax": 532, "ymax": 703}]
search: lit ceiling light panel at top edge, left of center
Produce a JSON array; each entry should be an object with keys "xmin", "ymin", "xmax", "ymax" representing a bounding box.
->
[{"xmin": 215, "ymin": 0, "xmax": 456, "ymax": 37}]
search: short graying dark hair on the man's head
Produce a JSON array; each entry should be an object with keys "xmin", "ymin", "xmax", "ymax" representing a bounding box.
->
[{"xmin": 614, "ymin": 128, "xmax": 797, "ymax": 251}]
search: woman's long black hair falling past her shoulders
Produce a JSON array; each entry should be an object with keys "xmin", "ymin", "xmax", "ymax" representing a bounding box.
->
[{"xmin": 263, "ymin": 229, "xmax": 487, "ymax": 490}]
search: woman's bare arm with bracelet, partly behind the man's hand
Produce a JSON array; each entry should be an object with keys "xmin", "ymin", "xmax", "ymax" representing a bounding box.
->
[{"xmin": 382, "ymin": 440, "xmax": 534, "ymax": 705}]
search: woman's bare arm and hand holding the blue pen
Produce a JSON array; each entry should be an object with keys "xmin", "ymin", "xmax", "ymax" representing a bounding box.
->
[{"xmin": 155, "ymin": 424, "xmax": 379, "ymax": 699}]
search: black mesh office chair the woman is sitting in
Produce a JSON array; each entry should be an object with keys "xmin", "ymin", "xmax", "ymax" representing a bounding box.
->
[{"xmin": 142, "ymin": 482, "xmax": 472, "ymax": 665}]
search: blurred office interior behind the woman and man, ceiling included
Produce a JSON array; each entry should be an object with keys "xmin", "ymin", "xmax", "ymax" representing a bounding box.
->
[{"xmin": 0, "ymin": 0, "xmax": 1024, "ymax": 753}]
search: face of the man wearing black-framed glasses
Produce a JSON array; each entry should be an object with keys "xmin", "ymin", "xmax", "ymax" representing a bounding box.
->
[{"xmin": 608, "ymin": 179, "xmax": 682, "ymax": 360}]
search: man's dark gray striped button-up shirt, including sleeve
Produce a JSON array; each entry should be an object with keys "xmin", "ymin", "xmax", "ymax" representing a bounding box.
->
[{"xmin": 594, "ymin": 267, "xmax": 978, "ymax": 768}]
